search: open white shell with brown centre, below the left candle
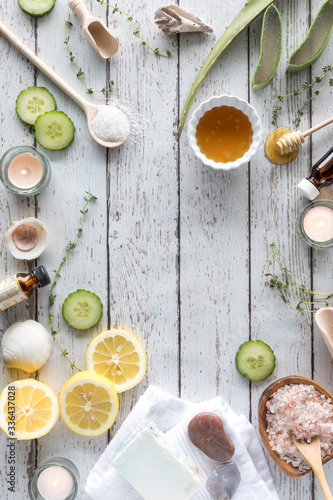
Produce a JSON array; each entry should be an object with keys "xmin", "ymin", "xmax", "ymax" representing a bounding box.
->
[{"xmin": 3, "ymin": 217, "xmax": 48, "ymax": 260}]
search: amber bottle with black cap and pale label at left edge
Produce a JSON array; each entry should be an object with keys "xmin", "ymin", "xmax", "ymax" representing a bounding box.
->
[{"xmin": 0, "ymin": 266, "xmax": 51, "ymax": 311}]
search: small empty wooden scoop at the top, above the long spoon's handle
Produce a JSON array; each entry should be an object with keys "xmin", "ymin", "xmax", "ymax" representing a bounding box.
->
[{"xmin": 68, "ymin": 0, "xmax": 118, "ymax": 59}]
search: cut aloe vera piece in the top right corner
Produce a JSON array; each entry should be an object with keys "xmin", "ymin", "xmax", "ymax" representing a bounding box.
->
[{"xmin": 287, "ymin": 0, "xmax": 333, "ymax": 71}]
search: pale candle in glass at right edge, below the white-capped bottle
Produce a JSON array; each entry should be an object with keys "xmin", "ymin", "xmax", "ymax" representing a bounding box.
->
[{"xmin": 303, "ymin": 206, "xmax": 333, "ymax": 243}]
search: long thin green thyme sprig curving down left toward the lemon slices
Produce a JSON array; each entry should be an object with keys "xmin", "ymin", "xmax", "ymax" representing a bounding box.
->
[{"xmin": 48, "ymin": 191, "xmax": 97, "ymax": 371}]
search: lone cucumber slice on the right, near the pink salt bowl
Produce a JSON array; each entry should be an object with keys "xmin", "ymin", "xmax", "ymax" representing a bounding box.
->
[{"xmin": 236, "ymin": 340, "xmax": 275, "ymax": 381}]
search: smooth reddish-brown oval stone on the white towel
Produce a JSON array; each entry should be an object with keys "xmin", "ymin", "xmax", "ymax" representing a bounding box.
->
[{"xmin": 187, "ymin": 412, "xmax": 235, "ymax": 462}]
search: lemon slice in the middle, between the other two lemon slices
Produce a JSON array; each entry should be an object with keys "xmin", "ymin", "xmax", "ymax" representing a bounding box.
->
[{"xmin": 59, "ymin": 371, "xmax": 119, "ymax": 436}]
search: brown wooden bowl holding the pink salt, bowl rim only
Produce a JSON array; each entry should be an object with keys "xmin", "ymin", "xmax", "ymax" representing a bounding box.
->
[{"xmin": 258, "ymin": 375, "xmax": 333, "ymax": 477}]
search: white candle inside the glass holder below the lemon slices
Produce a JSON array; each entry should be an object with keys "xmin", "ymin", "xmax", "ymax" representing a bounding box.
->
[{"xmin": 37, "ymin": 466, "xmax": 74, "ymax": 500}]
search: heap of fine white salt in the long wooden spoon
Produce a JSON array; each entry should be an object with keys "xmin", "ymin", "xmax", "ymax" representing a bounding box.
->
[{"xmin": 91, "ymin": 106, "xmax": 130, "ymax": 142}]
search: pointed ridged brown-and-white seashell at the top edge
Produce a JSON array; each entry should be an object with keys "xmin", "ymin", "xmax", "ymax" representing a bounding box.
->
[{"xmin": 154, "ymin": 4, "xmax": 213, "ymax": 35}]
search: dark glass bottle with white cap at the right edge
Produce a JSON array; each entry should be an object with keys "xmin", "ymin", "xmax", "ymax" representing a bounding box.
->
[{"xmin": 297, "ymin": 147, "xmax": 333, "ymax": 201}]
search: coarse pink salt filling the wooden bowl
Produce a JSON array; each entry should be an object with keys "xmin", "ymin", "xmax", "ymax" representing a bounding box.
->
[{"xmin": 266, "ymin": 384, "xmax": 333, "ymax": 472}]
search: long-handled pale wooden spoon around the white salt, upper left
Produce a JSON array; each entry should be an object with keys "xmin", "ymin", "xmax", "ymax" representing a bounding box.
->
[{"xmin": 0, "ymin": 23, "xmax": 131, "ymax": 148}]
